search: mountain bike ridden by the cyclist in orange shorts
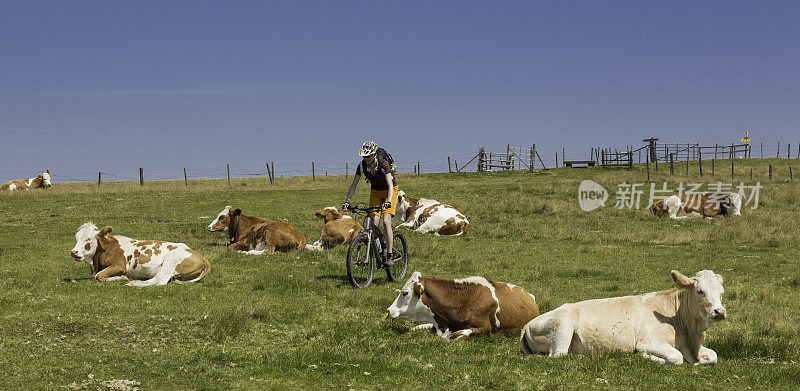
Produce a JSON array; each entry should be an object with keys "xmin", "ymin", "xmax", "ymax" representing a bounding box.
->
[{"xmin": 347, "ymin": 206, "xmax": 408, "ymax": 288}]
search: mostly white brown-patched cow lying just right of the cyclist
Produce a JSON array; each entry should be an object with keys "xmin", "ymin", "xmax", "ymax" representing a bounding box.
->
[{"xmin": 394, "ymin": 190, "xmax": 469, "ymax": 236}]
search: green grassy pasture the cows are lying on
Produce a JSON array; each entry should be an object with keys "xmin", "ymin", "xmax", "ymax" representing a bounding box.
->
[{"xmin": 0, "ymin": 159, "xmax": 800, "ymax": 390}]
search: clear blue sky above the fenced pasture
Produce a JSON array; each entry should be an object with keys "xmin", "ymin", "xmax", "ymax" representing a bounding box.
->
[{"xmin": 0, "ymin": 1, "xmax": 800, "ymax": 179}]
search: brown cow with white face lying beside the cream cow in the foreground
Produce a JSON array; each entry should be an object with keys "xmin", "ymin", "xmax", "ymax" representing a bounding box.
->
[{"xmin": 386, "ymin": 272, "xmax": 539, "ymax": 339}]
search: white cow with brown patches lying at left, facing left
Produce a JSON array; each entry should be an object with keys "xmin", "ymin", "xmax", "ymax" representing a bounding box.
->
[{"xmin": 70, "ymin": 222, "xmax": 211, "ymax": 286}]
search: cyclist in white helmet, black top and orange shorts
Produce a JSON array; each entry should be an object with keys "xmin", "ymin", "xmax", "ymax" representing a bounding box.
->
[{"xmin": 342, "ymin": 141, "xmax": 398, "ymax": 266}]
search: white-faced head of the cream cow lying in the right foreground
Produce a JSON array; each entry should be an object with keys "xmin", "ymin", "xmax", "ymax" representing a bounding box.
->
[{"xmin": 671, "ymin": 270, "xmax": 727, "ymax": 322}]
